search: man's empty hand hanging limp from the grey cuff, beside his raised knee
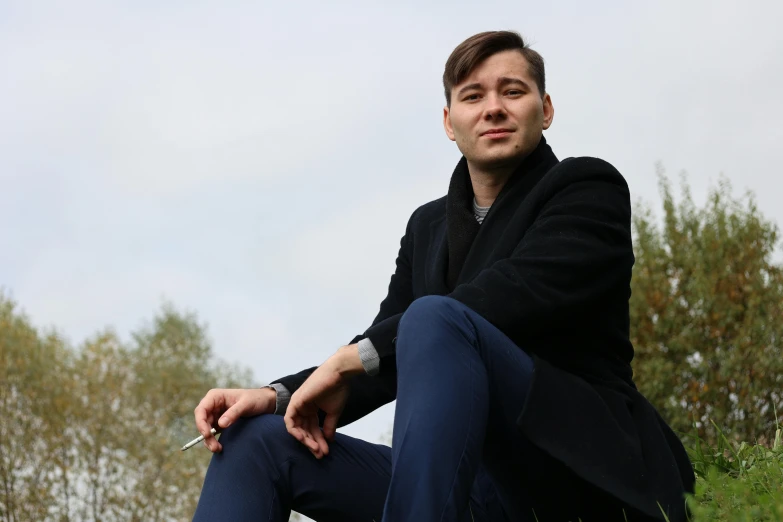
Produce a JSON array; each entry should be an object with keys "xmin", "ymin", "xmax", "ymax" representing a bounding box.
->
[{"xmin": 285, "ymin": 344, "xmax": 364, "ymax": 459}]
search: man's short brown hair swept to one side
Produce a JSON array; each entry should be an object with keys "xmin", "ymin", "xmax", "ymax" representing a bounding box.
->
[{"xmin": 443, "ymin": 31, "xmax": 546, "ymax": 106}]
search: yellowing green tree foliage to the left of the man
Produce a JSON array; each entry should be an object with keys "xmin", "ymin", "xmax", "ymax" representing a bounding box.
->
[{"xmin": 0, "ymin": 294, "xmax": 253, "ymax": 522}]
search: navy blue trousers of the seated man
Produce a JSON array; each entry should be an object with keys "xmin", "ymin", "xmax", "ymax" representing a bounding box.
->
[{"xmin": 193, "ymin": 296, "xmax": 536, "ymax": 522}]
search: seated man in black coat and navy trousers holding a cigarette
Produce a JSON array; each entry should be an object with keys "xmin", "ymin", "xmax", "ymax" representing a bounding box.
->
[{"xmin": 195, "ymin": 31, "xmax": 694, "ymax": 522}]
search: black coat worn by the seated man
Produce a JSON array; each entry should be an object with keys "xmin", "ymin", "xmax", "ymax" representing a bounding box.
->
[{"xmin": 276, "ymin": 138, "xmax": 694, "ymax": 522}]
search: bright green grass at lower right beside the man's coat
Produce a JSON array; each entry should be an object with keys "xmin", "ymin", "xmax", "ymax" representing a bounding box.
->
[{"xmin": 688, "ymin": 420, "xmax": 783, "ymax": 522}]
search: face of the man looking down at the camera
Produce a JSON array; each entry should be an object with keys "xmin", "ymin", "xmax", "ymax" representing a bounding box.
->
[{"xmin": 443, "ymin": 50, "xmax": 555, "ymax": 170}]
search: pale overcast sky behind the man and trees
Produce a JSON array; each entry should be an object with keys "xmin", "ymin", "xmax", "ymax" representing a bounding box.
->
[{"xmin": 0, "ymin": 0, "xmax": 783, "ymax": 440}]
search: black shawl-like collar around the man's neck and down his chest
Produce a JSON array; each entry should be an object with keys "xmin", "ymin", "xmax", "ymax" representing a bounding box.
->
[{"xmin": 446, "ymin": 136, "xmax": 558, "ymax": 290}]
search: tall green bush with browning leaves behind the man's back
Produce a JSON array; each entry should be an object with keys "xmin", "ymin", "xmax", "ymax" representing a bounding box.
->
[{"xmin": 630, "ymin": 168, "xmax": 783, "ymax": 442}]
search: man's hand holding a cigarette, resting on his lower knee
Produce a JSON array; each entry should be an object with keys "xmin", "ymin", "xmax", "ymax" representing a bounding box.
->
[{"xmin": 193, "ymin": 388, "xmax": 277, "ymax": 453}]
